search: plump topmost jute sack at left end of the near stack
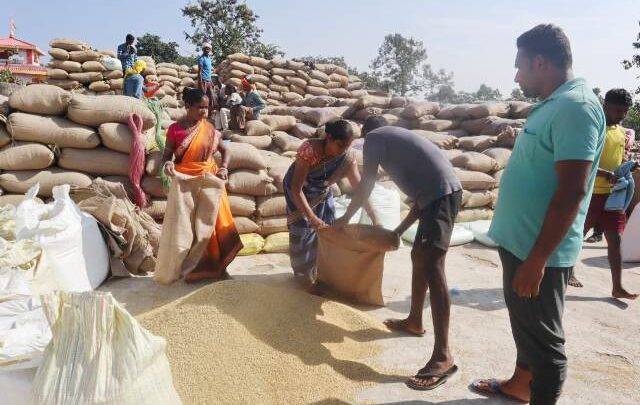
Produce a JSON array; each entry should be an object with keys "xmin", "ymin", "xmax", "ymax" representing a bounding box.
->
[{"xmin": 9, "ymin": 84, "xmax": 71, "ymax": 115}]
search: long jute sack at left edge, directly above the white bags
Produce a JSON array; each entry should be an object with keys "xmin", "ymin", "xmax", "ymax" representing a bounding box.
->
[{"xmin": 0, "ymin": 168, "xmax": 91, "ymax": 197}]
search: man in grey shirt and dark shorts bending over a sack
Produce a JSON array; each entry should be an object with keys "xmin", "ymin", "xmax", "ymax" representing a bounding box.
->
[{"xmin": 336, "ymin": 116, "xmax": 462, "ymax": 390}]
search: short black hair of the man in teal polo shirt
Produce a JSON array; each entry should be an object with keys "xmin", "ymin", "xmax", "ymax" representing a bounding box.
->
[{"xmin": 516, "ymin": 24, "xmax": 573, "ymax": 69}]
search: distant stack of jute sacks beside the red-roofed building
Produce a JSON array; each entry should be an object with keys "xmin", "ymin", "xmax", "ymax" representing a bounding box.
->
[{"xmin": 47, "ymin": 38, "xmax": 123, "ymax": 94}]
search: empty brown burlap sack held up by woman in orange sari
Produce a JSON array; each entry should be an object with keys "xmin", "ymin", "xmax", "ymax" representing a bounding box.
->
[{"xmin": 153, "ymin": 173, "xmax": 224, "ymax": 284}]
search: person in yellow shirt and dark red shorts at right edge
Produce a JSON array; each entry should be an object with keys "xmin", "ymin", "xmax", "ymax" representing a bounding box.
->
[{"xmin": 569, "ymin": 89, "xmax": 638, "ymax": 300}]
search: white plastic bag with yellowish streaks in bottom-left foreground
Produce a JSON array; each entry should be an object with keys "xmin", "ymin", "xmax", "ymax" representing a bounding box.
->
[{"xmin": 31, "ymin": 291, "xmax": 181, "ymax": 405}]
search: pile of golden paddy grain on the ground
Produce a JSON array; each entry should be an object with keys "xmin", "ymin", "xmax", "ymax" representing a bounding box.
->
[{"xmin": 140, "ymin": 280, "xmax": 394, "ymax": 404}]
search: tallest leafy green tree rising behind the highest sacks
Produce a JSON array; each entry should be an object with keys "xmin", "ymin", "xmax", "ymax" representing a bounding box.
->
[{"xmin": 182, "ymin": 0, "xmax": 282, "ymax": 64}]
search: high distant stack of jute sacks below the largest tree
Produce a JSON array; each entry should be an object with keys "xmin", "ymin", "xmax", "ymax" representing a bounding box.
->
[{"xmin": 217, "ymin": 53, "xmax": 364, "ymax": 105}]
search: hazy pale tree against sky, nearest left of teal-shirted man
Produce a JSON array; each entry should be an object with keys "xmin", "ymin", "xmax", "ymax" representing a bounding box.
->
[{"xmin": 371, "ymin": 34, "xmax": 427, "ymax": 96}]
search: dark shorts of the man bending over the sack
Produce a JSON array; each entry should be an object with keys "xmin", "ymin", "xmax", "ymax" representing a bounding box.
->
[{"xmin": 414, "ymin": 190, "xmax": 462, "ymax": 251}]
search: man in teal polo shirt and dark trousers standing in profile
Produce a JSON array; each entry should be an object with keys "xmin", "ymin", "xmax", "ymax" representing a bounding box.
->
[{"xmin": 472, "ymin": 25, "xmax": 605, "ymax": 405}]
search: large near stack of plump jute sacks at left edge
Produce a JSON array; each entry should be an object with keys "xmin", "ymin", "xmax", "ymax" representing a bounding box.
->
[{"xmin": 0, "ymin": 84, "xmax": 156, "ymax": 205}]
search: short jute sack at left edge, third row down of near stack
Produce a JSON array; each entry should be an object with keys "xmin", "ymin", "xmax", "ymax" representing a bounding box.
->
[{"xmin": 0, "ymin": 142, "xmax": 55, "ymax": 170}]
